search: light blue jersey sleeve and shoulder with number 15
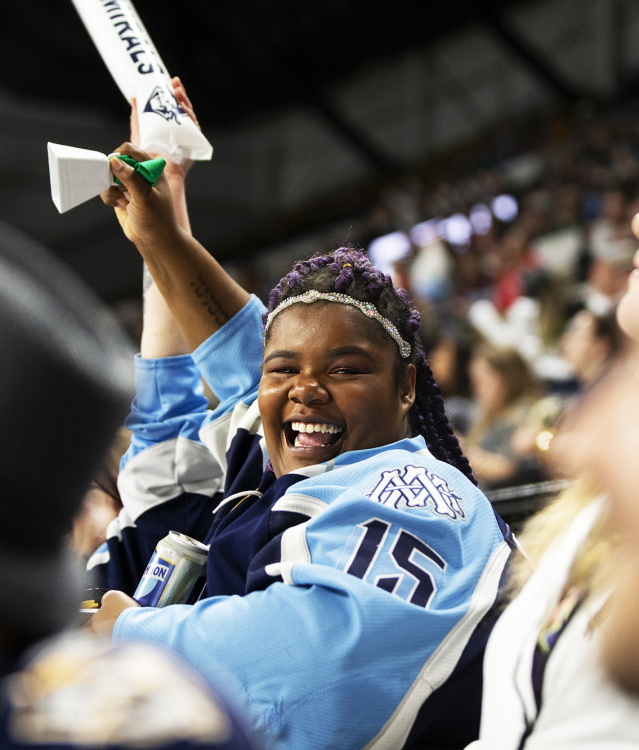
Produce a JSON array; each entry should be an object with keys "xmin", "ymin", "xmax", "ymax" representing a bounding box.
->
[{"xmin": 115, "ymin": 437, "xmax": 511, "ymax": 750}]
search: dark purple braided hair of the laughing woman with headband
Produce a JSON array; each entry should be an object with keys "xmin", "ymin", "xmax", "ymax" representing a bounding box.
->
[{"xmin": 263, "ymin": 247, "xmax": 477, "ymax": 484}]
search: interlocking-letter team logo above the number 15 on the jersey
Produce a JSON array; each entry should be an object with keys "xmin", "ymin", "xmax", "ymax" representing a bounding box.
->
[{"xmin": 366, "ymin": 466, "xmax": 466, "ymax": 521}]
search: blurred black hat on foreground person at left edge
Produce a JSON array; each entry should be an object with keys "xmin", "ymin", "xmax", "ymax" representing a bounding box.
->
[{"xmin": 0, "ymin": 222, "xmax": 133, "ymax": 635}]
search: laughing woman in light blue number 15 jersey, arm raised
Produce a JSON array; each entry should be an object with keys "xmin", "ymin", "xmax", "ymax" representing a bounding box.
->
[{"xmin": 86, "ymin": 134, "xmax": 514, "ymax": 750}]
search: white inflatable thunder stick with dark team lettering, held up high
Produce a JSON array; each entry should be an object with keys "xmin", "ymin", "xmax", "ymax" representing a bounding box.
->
[{"xmin": 73, "ymin": 0, "xmax": 213, "ymax": 163}]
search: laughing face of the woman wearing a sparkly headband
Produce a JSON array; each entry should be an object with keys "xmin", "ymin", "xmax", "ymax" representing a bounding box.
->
[{"xmin": 258, "ymin": 302, "xmax": 415, "ymax": 475}]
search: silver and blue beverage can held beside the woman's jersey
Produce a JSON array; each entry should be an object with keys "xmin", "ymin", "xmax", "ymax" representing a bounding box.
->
[{"xmin": 133, "ymin": 531, "xmax": 209, "ymax": 607}]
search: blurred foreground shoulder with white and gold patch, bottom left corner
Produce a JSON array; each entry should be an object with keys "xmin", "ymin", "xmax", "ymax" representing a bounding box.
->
[{"xmin": 0, "ymin": 632, "xmax": 254, "ymax": 750}]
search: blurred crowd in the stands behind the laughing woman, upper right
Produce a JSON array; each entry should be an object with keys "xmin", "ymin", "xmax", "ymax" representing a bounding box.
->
[{"xmin": 262, "ymin": 101, "xmax": 639, "ymax": 489}]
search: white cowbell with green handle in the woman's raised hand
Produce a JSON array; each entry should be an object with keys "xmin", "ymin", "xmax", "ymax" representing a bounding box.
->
[{"xmin": 48, "ymin": 143, "xmax": 166, "ymax": 213}]
